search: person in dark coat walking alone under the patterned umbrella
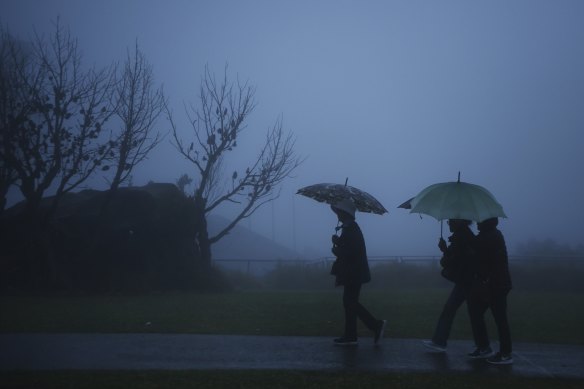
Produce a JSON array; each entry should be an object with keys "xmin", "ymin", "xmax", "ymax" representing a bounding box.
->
[{"xmin": 331, "ymin": 199, "xmax": 386, "ymax": 346}]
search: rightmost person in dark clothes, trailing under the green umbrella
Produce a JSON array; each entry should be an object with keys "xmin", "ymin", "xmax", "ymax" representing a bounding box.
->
[{"xmin": 468, "ymin": 218, "xmax": 513, "ymax": 364}]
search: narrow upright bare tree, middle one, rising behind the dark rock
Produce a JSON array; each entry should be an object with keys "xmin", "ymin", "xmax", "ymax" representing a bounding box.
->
[{"xmin": 99, "ymin": 42, "xmax": 166, "ymax": 209}]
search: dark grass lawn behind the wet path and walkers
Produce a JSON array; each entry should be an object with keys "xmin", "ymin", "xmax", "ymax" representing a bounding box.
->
[{"xmin": 0, "ymin": 287, "xmax": 584, "ymax": 344}]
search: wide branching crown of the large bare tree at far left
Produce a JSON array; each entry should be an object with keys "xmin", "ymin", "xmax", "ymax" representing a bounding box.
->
[{"xmin": 2, "ymin": 21, "xmax": 113, "ymax": 220}]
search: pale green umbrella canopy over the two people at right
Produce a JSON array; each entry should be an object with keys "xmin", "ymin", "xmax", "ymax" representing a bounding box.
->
[{"xmin": 402, "ymin": 180, "xmax": 507, "ymax": 222}]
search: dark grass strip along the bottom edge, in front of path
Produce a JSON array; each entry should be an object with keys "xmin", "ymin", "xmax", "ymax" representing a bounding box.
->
[{"xmin": 0, "ymin": 370, "xmax": 583, "ymax": 389}]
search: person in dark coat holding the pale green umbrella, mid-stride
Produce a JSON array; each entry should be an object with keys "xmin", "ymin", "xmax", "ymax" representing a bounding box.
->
[{"xmin": 422, "ymin": 219, "xmax": 475, "ymax": 352}]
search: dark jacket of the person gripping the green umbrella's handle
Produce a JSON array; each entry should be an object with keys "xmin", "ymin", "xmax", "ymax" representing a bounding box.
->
[{"xmin": 440, "ymin": 227, "xmax": 477, "ymax": 286}]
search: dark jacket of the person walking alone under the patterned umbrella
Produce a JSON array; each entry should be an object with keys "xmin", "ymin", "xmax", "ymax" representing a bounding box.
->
[{"xmin": 332, "ymin": 220, "xmax": 371, "ymax": 285}]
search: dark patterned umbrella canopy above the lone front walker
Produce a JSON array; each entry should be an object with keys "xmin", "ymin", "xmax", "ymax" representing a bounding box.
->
[{"xmin": 296, "ymin": 183, "xmax": 387, "ymax": 215}]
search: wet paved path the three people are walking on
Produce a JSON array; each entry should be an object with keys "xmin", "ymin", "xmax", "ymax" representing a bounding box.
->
[{"xmin": 0, "ymin": 334, "xmax": 584, "ymax": 379}]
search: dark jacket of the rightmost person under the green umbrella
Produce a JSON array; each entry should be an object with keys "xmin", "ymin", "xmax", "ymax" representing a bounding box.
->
[{"xmin": 475, "ymin": 227, "xmax": 512, "ymax": 291}]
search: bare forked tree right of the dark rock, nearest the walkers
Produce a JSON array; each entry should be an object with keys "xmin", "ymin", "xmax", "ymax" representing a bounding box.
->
[{"xmin": 169, "ymin": 67, "xmax": 302, "ymax": 265}]
